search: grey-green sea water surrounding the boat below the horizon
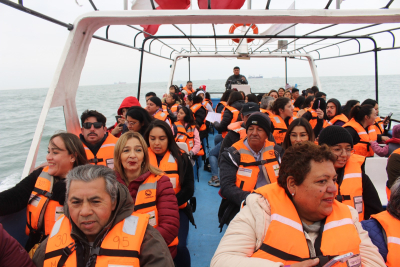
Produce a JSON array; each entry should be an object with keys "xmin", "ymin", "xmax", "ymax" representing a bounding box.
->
[{"xmin": 0, "ymin": 75, "xmax": 400, "ymax": 191}]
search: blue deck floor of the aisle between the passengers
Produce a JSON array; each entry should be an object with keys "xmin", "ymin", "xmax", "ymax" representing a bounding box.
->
[{"xmin": 188, "ymin": 134, "xmax": 226, "ymax": 267}]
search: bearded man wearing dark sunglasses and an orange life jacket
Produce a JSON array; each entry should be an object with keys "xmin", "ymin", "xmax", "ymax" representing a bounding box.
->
[{"xmin": 79, "ymin": 110, "xmax": 118, "ymax": 169}]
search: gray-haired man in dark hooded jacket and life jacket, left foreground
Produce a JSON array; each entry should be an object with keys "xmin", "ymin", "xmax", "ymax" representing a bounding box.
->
[{"xmin": 33, "ymin": 165, "xmax": 174, "ymax": 267}]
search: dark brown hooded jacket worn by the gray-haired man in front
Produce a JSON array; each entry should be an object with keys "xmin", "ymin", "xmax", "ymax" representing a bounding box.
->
[{"xmin": 33, "ymin": 183, "xmax": 174, "ymax": 267}]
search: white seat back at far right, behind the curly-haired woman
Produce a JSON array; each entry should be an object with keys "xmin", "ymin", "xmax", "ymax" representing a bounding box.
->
[{"xmin": 365, "ymin": 156, "xmax": 387, "ymax": 206}]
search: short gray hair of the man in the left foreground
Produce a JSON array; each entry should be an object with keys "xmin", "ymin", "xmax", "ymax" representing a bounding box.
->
[{"xmin": 66, "ymin": 164, "xmax": 118, "ymax": 203}]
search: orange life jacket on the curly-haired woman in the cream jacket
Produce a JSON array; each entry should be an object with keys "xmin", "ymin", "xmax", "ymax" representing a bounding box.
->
[{"xmin": 251, "ymin": 183, "xmax": 361, "ymax": 267}]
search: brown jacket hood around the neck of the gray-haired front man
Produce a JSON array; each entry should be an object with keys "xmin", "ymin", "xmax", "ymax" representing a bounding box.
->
[{"xmin": 64, "ymin": 183, "xmax": 134, "ymax": 247}]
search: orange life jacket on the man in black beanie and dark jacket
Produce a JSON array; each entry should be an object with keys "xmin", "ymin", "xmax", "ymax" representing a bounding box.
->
[{"xmin": 232, "ymin": 139, "xmax": 279, "ymax": 192}]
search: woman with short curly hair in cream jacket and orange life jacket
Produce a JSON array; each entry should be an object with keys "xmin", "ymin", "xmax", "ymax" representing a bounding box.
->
[{"xmin": 211, "ymin": 142, "xmax": 385, "ymax": 267}]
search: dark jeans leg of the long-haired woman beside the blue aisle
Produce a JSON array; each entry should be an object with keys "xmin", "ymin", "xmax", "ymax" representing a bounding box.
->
[{"xmin": 174, "ymin": 210, "xmax": 190, "ymax": 267}]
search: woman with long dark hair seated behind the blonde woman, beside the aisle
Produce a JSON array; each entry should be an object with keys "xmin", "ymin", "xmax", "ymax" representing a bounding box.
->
[{"xmin": 145, "ymin": 121, "xmax": 194, "ymax": 266}]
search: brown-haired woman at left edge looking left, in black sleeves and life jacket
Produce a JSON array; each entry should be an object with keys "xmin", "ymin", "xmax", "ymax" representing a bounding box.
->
[{"xmin": 0, "ymin": 133, "xmax": 87, "ymax": 256}]
